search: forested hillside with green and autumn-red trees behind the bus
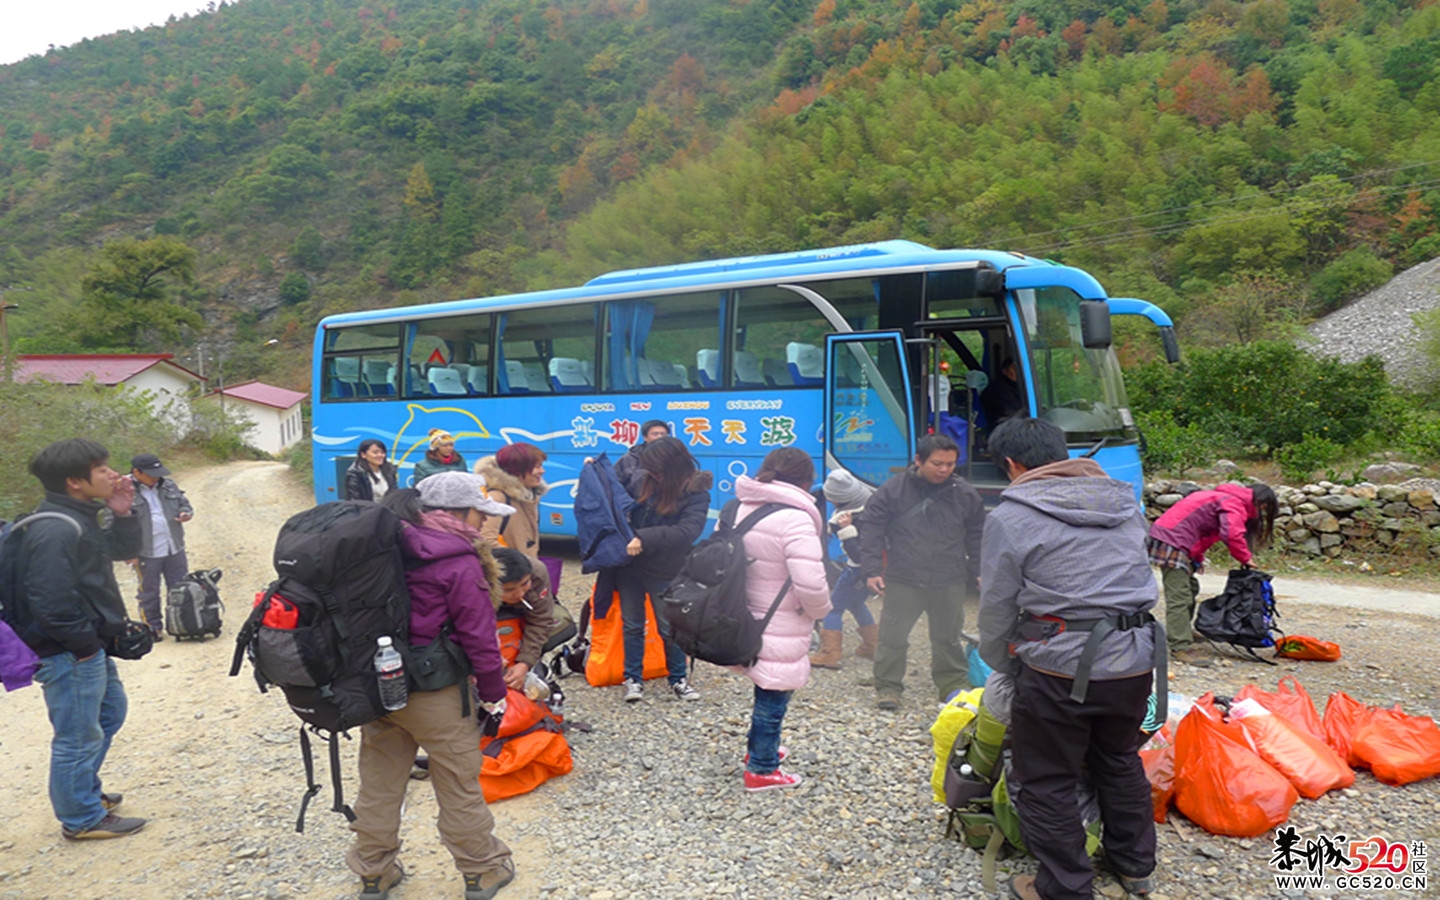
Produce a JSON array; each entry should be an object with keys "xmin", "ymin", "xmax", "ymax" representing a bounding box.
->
[{"xmin": 0, "ymin": 0, "xmax": 1440, "ymax": 374}]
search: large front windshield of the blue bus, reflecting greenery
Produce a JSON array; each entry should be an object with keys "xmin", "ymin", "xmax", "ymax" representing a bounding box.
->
[{"xmin": 1015, "ymin": 288, "xmax": 1133, "ymax": 439}]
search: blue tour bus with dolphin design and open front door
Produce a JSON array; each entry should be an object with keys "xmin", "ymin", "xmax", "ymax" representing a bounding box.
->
[{"xmin": 312, "ymin": 240, "xmax": 1176, "ymax": 536}]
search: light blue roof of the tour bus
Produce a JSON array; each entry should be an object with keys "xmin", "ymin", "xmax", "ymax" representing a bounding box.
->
[{"xmin": 320, "ymin": 240, "xmax": 1056, "ymax": 327}]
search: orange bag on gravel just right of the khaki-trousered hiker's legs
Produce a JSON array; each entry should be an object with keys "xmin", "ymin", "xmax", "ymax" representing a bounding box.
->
[{"xmin": 480, "ymin": 688, "xmax": 575, "ymax": 804}]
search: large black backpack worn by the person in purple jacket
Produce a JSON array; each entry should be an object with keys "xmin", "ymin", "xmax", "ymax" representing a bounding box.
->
[{"xmin": 230, "ymin": 500, "xmax": 410, "ymax": 831}]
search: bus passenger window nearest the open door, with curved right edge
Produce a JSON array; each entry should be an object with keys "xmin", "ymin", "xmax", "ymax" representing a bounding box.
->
[{"xmin": 732, "ymin": 288, "xmax": 832, "ymax": 389}]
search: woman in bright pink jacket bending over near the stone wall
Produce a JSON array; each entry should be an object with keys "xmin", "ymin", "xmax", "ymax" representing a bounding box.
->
[{"xmin": 1145, "ymin": 482, "xmax": 1280, "ymax": 667}]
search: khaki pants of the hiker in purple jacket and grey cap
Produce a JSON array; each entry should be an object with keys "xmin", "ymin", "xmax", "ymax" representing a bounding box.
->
[{"xmin": 346, "ymin": 685, "xmax": 510, "ymax": 878}]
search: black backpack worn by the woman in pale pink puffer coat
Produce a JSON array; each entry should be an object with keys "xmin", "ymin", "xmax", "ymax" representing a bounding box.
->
[{"xmin": 661, "ymin": 500, "xmax": 791, "ymax": 665}]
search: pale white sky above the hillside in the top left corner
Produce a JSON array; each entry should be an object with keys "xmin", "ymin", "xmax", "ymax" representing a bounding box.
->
[{"xmin": 0, "ymin": 0, "xmax": 206, "ymax": 65}]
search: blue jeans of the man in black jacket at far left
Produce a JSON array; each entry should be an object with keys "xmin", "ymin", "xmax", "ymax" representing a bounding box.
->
[{"xmin": 35, "ymin": 651, "xmax": 130, "ymax": 831}]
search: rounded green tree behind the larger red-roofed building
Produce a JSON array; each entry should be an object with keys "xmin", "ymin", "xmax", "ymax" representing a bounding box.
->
[{"xmin": 68, "ymin": 236, "xmax": 203, "ymax": 348}]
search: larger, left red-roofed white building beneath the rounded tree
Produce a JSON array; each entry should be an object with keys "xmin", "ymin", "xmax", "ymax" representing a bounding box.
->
[{"xmin": 14, "ymin": 353, "xmax": 204, "ymax": 429}]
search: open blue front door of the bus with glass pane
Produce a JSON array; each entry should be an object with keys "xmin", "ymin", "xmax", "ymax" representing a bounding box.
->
[{"xmin": 824, "ymin": 331, "xmax": 916, "ymax": 485}]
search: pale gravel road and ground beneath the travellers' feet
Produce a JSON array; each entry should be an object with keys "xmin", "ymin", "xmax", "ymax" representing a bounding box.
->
[{"xmin": 0, "ymin": 462, "xmax": 1440, "ymax": 900}]
